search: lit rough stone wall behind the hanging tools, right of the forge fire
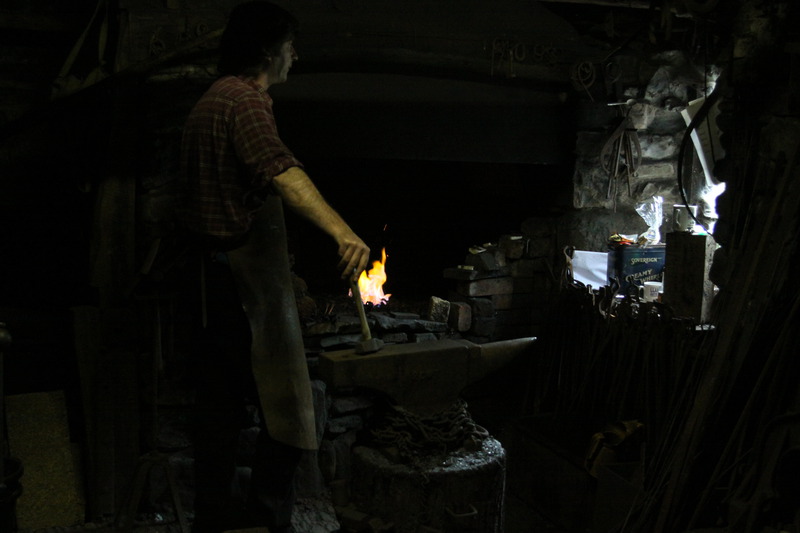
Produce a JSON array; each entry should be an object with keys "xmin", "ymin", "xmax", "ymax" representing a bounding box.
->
[{"xmin": 558, "ymin": 48, "xmax": 718, "ymax": 251}]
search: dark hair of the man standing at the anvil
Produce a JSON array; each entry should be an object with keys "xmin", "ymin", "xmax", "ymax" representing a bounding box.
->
[{"xmin": 217, "ymin": 0, "xmax": 299, "ymax": 76}]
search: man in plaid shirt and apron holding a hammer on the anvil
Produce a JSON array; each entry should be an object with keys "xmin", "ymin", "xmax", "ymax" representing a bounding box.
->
[{"xmin": 180, "ymin": 1, "xmax": 369, "ymax": 533}]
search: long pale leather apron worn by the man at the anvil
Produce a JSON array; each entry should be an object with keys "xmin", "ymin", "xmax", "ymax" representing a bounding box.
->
[{"xmin": 227, "ymin": 195, "xmax": 318, "ymax": 450}]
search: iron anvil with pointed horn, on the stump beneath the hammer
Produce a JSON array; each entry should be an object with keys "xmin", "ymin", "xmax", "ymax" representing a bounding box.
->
[{"xmin": 319, "ymin": 337, "xmax": 536, "ymax": 414}]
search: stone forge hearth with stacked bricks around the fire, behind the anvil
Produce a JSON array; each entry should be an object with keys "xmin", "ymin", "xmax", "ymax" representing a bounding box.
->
[{"xmin": 296, "ymin": 222, "xmax": 557, "ymax": 351}]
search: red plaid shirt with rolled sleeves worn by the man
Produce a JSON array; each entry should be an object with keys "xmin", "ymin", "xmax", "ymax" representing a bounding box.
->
[{"xmin": 180, "ymin": 76, "xmax": 302, "ymax": 241}]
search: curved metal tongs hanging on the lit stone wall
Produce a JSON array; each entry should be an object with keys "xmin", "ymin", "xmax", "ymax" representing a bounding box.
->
[{"xmin": 600, "ymin": 100, "xmax": 642, "ymax": 198}]
